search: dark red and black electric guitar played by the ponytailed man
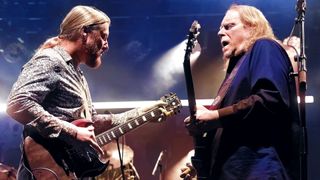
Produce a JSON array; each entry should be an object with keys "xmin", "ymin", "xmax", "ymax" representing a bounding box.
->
[{"xmin": 24, "ymin": 93, "xmax": 181, "ymax": 180}]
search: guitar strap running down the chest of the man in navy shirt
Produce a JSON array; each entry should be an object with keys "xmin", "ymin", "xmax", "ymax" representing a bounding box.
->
[{"xmin": 209, "ymin": 53, "xmax": 247, "ymax": 175}]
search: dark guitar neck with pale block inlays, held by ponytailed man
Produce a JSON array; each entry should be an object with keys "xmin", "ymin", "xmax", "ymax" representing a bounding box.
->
[{"xmin": 96, "ymin": 108, "xmax": 163, "ymax": 146}]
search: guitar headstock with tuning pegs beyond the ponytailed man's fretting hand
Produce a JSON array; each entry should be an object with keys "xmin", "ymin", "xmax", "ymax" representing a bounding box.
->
[{"xmin": 160, "ymin": 92, "xmax": 182, "ymax": 114}]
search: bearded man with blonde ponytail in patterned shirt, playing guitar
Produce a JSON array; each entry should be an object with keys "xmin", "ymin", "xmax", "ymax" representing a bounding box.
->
[{"xmin": 7, "ymin": 5, "xmax": 169, "ymax": 180}]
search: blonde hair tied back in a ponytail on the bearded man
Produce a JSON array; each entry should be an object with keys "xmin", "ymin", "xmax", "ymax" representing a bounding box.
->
[{"xmin": 39, "ymin": 5, "xmax": 111, "ymax": 49}]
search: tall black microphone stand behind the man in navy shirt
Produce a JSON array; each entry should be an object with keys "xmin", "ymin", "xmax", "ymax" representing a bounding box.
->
[{"xmin": 296, "ymin": 0, "xmax": 308, "ymax": 180}]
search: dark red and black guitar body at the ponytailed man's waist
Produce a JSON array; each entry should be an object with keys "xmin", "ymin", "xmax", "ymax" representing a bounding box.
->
[{"xmin": 24, "ymin": 129, "xmax": 108, "ymax": 179}]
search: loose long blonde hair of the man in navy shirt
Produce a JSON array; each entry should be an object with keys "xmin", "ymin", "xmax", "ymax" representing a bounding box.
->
[{"xmin": 229, "ymin": 4, "xmax": 276, "ymax": 50}]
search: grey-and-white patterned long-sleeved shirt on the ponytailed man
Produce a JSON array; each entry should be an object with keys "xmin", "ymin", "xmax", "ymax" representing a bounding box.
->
[{"xmin": 7, "ymin": 46, "xmax": 139, "ymax": 138}]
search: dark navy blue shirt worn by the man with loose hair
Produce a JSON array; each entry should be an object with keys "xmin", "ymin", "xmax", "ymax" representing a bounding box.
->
[{"xmin": 214, "ymin": 39, "xmax": 298, "ymax": 179}]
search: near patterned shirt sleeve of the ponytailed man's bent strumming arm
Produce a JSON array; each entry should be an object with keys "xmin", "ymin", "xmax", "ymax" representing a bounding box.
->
[{"xmin": 7, "ymin": 56, "xmax": 76, "ymax": 138}]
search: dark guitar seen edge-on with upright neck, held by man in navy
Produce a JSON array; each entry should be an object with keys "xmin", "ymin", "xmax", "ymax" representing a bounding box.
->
[{"xmin": 183, "ymin": 21, "xmax": 214, "ymax": 179}]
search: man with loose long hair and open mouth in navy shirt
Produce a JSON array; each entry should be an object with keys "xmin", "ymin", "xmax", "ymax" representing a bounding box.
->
[{"xmin": 185, "ymin": 5, "xmax": 299, "ymax": 180}]
